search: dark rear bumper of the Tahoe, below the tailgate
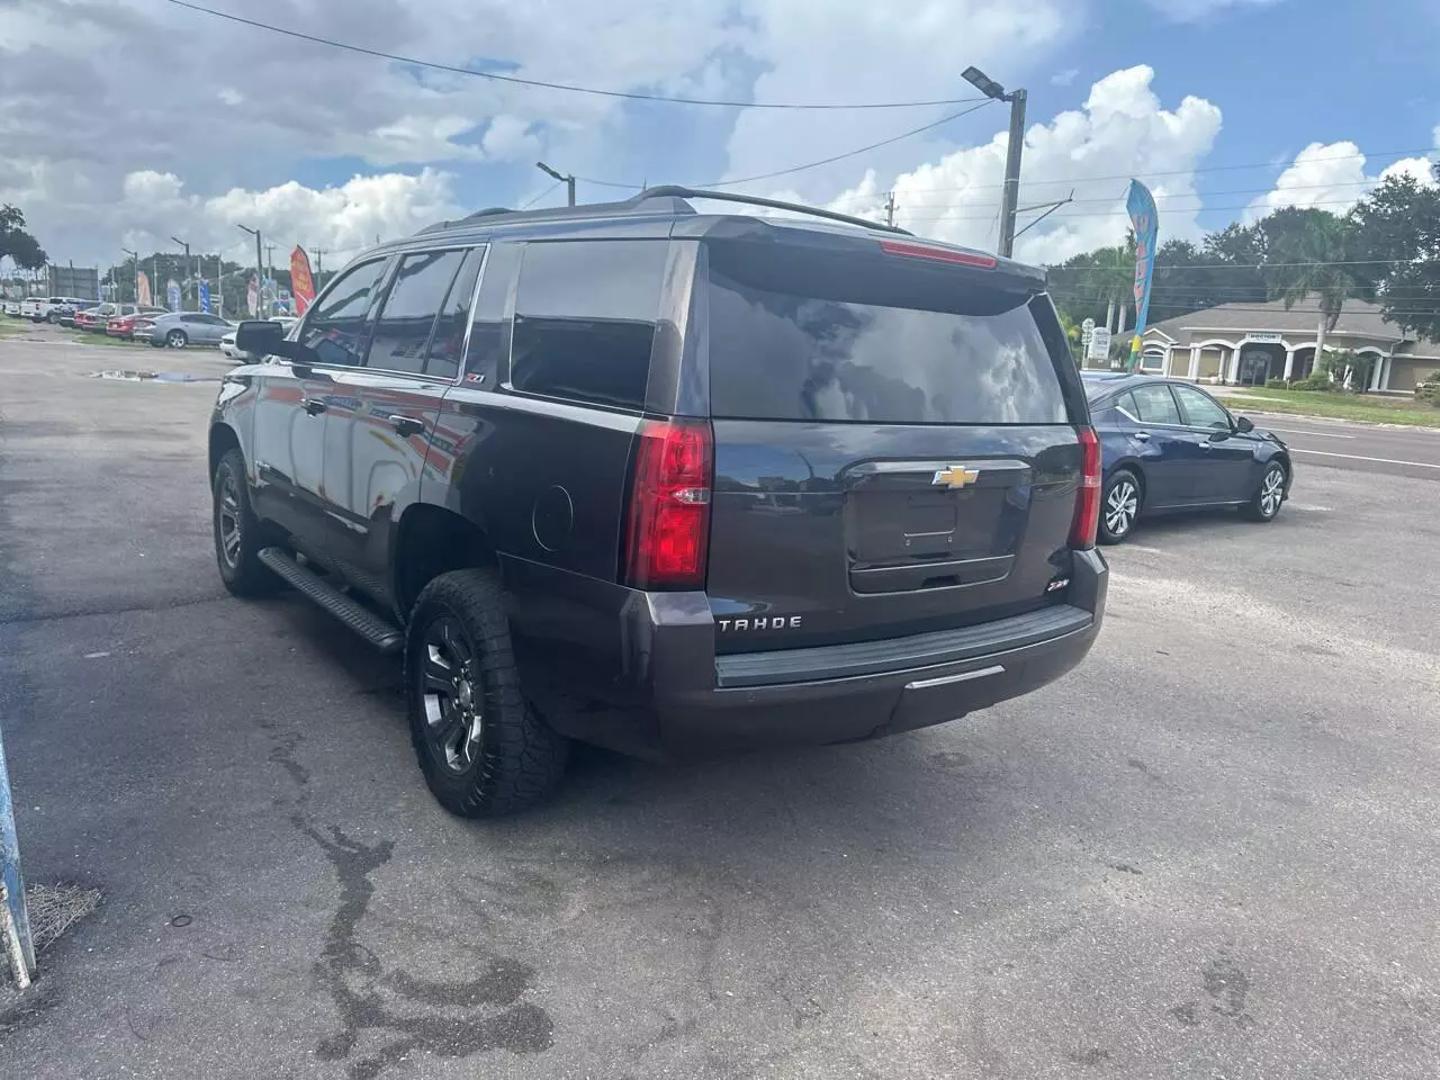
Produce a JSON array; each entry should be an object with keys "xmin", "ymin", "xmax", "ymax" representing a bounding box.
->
[{"xmin": 505, "ymin": 552, "xmax": 1109, "ymax": 757}]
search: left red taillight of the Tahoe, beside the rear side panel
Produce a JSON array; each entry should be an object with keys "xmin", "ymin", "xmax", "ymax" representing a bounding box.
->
[{"xmin": 625, "ymin": 420, "xmax": 714, "ymax": 589}]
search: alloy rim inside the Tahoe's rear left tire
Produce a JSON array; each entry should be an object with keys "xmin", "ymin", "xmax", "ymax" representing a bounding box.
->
[{"xmin": 419, "ymin": 616, "xmax": 485, "ymax": 773}]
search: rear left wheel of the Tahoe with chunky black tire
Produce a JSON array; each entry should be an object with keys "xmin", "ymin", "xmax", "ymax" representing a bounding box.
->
[{"xmin": 405, "ymin": 569, "xmax": 569, "ymax": 818}]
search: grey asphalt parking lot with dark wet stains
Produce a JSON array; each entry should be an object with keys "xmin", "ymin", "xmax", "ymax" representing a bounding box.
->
[{"xmin": 8, "ymin": 330, "xmax": 1440, "ymax": 1080}]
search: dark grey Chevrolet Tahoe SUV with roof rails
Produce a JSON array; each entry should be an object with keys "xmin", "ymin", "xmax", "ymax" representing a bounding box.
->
[{"xmin": 209, "ymin": 187, "xmax": 1107, "ymax": 815}]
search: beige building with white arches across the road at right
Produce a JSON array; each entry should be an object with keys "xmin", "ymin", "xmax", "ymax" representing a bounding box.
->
[{"xmin": 1082, "ymin": 300, "xmax": 1440, "ymax": 393}]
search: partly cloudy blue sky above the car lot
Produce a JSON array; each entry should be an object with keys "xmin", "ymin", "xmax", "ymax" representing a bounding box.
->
[{"xmin": 0, "ymin": 0, "xmax": 1440, "ymax": 269}]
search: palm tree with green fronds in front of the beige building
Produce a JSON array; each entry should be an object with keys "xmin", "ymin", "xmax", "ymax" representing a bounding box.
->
[{"xmin": 1260, "ymin": 206, "xmax": 1372, "ymax": 385}]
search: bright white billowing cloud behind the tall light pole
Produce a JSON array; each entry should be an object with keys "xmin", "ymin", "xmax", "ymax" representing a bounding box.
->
[{"xmin": 831, "ymin": 66, "xmax": 1221, "ymax": 264}]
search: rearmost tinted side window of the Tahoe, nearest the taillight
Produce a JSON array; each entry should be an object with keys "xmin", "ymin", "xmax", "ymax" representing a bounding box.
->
[{"xmin": 510, "ymin": 240, "xmax": 668, "ymax": 409}]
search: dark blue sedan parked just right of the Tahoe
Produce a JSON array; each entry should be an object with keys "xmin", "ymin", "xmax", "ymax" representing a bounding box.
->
[{"xmin": 1084, "ymin": 374, "xmax": 1295, "ymax": 544}]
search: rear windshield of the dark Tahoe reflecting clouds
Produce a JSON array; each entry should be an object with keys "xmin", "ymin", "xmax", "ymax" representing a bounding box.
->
[{"xmin": 708, "ymin": 242, "xmax": 1068, "ymax": 423}]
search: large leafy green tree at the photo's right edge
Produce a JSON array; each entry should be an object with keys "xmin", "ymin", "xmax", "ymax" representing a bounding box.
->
[{"xmin": 1351, "ymin": 164, "xmax": 1440, "ymax": 341}]
